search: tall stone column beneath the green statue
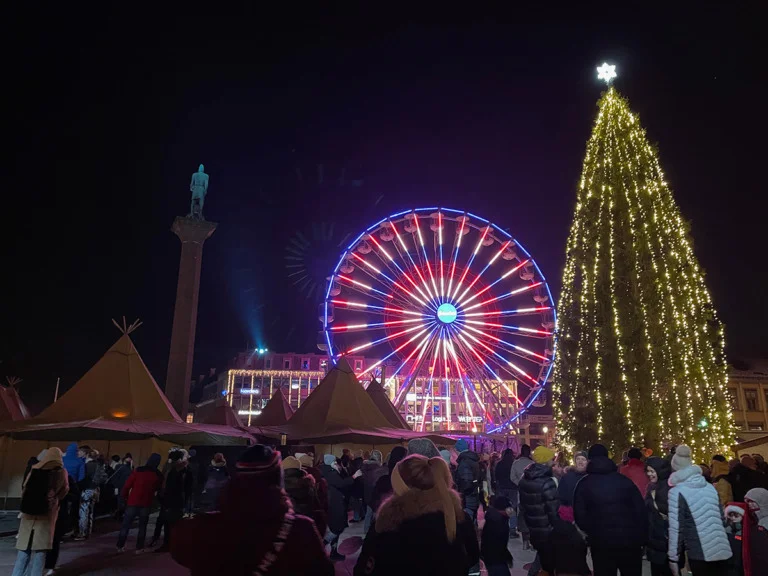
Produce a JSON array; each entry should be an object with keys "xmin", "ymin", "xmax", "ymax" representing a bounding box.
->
[{"xmin": 165, "ymin": 216, "xmax": 217, "ymax": 420}]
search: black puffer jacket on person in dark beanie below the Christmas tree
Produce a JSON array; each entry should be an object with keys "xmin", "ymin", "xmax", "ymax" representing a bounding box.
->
[{"xmin": 573, "ymin": 456, "xmax": 648, "ymax": 548}]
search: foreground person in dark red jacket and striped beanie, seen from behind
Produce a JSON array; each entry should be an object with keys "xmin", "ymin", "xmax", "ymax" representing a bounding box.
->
[{"xmin": 171, "ymin": 444, "xmax": 334, "ymax": 576}]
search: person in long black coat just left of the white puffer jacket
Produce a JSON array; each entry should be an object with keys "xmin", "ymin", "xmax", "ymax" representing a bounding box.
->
[{"xmin": 645, "ymin": 458, "xmax": 672, "ymax": 576}]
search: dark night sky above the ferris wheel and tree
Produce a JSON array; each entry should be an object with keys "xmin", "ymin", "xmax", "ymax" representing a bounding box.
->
[{"xmin": 0, "ymin": 2, "xmax": 768, "ymax": 409}]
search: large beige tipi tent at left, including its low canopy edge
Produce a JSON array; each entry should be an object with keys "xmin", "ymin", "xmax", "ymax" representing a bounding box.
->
[{"xmin": 0, "ymin": 330, "xmax": 253, "ymax": 508}]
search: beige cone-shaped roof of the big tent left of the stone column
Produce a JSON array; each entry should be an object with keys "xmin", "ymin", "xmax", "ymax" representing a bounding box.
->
[{"xmin": 34, "ymin": 334, "xmax": 181, "ymax": 423}]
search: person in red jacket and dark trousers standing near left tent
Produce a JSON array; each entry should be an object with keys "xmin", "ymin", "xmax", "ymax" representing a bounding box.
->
[{"xmin": 117, "ymin": 453, "xmax": 163, "ymax": 552}]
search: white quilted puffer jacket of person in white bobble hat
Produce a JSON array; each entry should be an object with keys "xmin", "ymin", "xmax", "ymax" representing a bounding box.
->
[{"xmin": 668, "ymin": 466, "xmax": 732, "ymax": 562}]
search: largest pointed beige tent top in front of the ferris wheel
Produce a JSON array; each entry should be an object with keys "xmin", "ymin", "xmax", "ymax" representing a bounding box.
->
[{"xmin": 288, "ymin": 358, "xmax": 391, "ymax": 438}]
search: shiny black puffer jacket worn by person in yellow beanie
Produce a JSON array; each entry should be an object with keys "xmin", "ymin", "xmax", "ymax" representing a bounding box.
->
[{"xmin": 518, "ymin": 464, "xmax": 561, "ymax": 547}]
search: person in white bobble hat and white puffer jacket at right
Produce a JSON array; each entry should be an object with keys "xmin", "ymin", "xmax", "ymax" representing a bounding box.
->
[{"xmin": 667, "ymin": 444, "xmax": 732, "ymax": 576}]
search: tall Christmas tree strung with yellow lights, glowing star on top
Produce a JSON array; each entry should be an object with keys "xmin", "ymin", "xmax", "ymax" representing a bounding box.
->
[{"xmin": 553, "ymin": 64, "xmax": 733, "ymax": 459}]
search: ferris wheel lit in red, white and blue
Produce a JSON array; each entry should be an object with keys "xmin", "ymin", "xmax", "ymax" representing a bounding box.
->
[{"xmin": 318, "ymin": 208, "xmax": 555, "ymax": 433}]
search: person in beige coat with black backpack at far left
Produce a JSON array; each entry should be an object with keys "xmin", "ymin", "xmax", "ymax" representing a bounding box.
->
[{"xmin": 13, "ymin": 448, "xmax": 69, "ymax": 576}]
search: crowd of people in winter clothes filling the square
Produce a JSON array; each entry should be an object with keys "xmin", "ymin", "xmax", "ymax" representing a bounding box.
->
[{"xmin": 13, "ymin": 438, "xmax": 768, "ymax": 576}]
